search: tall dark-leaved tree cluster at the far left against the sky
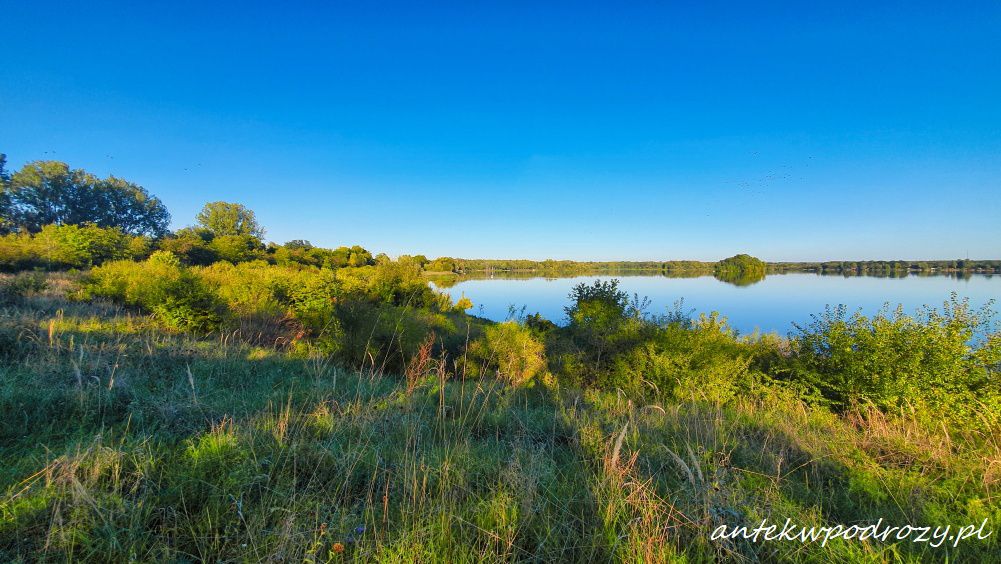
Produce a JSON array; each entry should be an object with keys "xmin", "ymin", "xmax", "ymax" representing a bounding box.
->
[{"xmin": 0, "ymin": 160, "xmax": 170, "ymax": 236}]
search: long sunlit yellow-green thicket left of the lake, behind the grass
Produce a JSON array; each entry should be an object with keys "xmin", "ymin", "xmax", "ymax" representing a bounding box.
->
[{"xmin": 74, "ymin": 250, "xmax": 478, "ymax": 364}]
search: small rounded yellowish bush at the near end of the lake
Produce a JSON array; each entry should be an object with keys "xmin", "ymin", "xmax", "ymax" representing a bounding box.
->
[{"xmin": 469, "ymin": 322, "xmax": 546, "ymax": 385}]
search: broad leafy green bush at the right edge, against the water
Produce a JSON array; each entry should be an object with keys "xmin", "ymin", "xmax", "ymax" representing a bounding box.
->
[{"xmin": 793, "ymin": 296, "xmax": 1001, "ymax": 426}]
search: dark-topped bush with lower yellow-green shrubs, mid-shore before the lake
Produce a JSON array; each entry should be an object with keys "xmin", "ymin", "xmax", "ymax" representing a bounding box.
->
[{"xmin": 552, "ymin": 280, "xmax": 768, "ymax": 403}]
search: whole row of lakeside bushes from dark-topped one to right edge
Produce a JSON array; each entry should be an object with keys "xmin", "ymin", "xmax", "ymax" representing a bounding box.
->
[{"xmin": 544, "ymin": 280, "xmax": 1001, "ymax": 427}]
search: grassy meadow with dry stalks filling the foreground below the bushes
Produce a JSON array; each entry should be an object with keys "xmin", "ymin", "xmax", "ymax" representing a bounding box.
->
[{"xmin": 0, "ymin": 275, "xmax": 1001, "ymax": 562}]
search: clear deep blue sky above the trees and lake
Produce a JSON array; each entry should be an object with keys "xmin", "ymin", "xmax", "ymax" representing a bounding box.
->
[{"xmin": 0, "ymin": 1, "xmax": 1001, "ymax": 260}]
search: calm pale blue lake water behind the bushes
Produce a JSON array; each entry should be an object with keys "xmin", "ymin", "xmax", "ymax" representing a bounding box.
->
[{"xmin": 432, "ymin": 273, "xmax": 1001, "ymax": 335}]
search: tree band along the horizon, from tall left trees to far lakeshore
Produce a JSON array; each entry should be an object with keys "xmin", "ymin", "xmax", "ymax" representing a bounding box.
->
[{"xmin": 0, "ymin": 154, "xmax": 1001, "ymax": 276}]
